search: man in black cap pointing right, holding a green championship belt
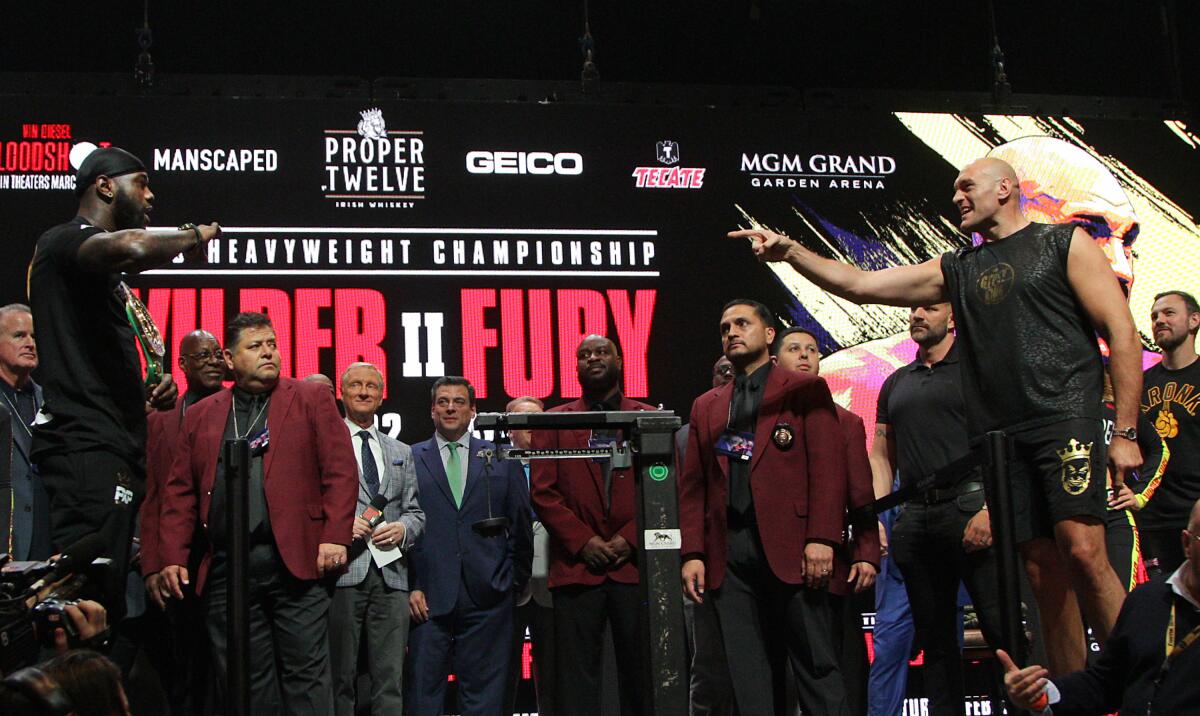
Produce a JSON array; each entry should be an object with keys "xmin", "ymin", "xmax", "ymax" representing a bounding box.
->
[{"xmin": 29, "ymin": 146, "xmax": 221, "ymax": 618}]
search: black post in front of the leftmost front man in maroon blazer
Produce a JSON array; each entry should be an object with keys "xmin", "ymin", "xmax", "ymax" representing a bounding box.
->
[{"xmin": 224, "ymin": 439, "xmax": 250, "ymax": 716}]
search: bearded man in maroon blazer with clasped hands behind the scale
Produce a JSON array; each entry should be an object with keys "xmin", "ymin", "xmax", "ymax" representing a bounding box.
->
[{"xmin": 530, "ymin": 335, "xmax": 654, "ymax": 716}]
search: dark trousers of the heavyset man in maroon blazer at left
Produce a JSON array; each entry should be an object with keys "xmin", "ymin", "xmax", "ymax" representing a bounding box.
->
[{"xmin": 204, "ymin": 544, "xmax": 332, "ymax": 716}]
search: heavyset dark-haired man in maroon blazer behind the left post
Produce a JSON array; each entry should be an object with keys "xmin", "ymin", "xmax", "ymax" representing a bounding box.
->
[{"xmin": 160, "ymin": 313, "xmax": 358, "ymax": 716}]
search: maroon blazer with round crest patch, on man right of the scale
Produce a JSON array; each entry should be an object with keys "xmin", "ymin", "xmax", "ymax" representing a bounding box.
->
[{"xmin": 679, "ymin": 366, "xmax": 846, "ymax": 589}]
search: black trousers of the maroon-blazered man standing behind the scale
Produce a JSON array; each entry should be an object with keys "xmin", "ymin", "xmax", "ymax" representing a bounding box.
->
[{"xmin": 551, "ymin": 580, "xmax": 648, "ymax": 716}]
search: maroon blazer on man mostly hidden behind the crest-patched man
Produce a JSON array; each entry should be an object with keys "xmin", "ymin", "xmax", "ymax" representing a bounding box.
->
[{"xmin": 829, "ymin": 405, "xmax": 880, "ymax": 595}]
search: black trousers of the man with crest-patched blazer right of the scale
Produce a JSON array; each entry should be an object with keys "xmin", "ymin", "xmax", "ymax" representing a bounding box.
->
[{"xmin": 705, "ymin": 525, "xmax": 848, "ymax": 716}]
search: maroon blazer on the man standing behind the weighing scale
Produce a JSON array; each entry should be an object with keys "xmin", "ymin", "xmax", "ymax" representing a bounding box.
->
[{"xmin": 529, "ymin": 398, "xmax": 655, "ymax": 586}]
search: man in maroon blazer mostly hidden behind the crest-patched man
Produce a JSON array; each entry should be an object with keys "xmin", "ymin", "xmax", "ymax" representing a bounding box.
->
[{"xmin": 774, "ymin": 326, "xmax": 881, "ymax": 714}]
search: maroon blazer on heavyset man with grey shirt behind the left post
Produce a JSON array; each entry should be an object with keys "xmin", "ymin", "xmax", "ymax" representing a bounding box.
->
[{"xmin": 160, "ymin": 378, "xmax": 359, "ymax": 594}]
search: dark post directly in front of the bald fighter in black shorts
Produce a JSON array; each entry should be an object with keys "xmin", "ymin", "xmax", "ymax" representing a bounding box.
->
[{"xmin": 984, "ymin": 431, "xmax": 1027, "ymax": 664}]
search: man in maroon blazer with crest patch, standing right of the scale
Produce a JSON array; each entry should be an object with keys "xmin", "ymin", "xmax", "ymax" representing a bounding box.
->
[{"xmin": 679, "ymin": 299, "xmax": 847, "ymax": 716}]
